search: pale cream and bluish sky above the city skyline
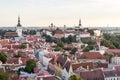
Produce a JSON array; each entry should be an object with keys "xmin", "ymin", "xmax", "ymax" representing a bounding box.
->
[{"xmin": 0, "ymin": 0, "xmax": 120, "ymax": 27}]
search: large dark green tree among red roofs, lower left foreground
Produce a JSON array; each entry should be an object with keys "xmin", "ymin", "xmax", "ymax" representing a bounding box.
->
[{"xmin": 25, "ymin": 59, "xmax": 36, "ymax": 73}]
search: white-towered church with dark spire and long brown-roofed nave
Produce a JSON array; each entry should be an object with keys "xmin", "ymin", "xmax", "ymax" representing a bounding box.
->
[{"xmin": 4, "ymin": 16, "xmax": 22, "ymax": 39}]
